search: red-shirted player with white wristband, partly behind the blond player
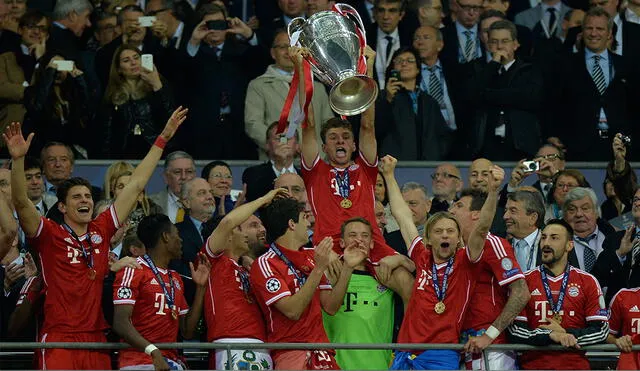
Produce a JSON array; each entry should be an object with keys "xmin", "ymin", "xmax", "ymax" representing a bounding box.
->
[{"xmin": 449, "ymin": 189, "xmax": 529, "ymax": 370}]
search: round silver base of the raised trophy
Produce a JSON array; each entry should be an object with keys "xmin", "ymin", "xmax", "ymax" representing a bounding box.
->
[{"xmin": 329, "ymin": 75, "xmax": 378, "ymax": 116}]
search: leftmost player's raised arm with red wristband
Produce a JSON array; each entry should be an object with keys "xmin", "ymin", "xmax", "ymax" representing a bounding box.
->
[{"xmin": 114, "ymin": 107, "xmax": 188, "ymax": 224}]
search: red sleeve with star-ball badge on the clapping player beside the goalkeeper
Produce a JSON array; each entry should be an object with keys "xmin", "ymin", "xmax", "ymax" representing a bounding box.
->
[{"xmin": 250, "ymin": 255, "xmax": 292, "ymax": 305}]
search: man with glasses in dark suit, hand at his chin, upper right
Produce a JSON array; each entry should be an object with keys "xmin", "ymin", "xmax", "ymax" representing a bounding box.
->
[{"xmin": 468, "ymin": 20, "xmax": 543, "ymax": 160}]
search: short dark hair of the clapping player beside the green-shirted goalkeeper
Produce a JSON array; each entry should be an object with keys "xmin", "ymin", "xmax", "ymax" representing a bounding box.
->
[{"xmin": 260, "ymin": 198, "xmax": 305, "ymax": 243}]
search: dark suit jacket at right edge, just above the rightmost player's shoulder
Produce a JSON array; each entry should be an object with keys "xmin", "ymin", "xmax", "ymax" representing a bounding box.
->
[{"xmin": 592, "ymin": 231, "xmax": 640, "ymax": 304}]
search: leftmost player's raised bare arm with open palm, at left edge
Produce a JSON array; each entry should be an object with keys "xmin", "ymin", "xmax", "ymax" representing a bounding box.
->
[{"xmin": 2, "ymin": 122, "xmax": 40, "ymax": 237}]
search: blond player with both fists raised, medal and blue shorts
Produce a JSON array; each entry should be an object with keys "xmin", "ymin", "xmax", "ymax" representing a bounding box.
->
[{"xmin": 381, "ymin": 156, "xmax": 504, "ymax": 370}]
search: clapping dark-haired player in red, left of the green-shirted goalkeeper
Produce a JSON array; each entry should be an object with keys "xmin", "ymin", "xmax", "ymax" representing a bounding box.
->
[{"xmin": 250, "ymin": 198, "xmax": 366, "ymax": 370}]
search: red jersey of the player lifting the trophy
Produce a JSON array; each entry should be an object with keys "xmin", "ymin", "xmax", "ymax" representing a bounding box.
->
[{"xmin": 302, "ymin": 153, "xmax": 395, "ymax": 263}]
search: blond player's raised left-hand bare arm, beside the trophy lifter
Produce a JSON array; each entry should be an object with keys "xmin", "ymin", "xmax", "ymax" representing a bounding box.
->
[{"xmin": 380, "ymin": 155, "xmax": 420, "ymax": 246}]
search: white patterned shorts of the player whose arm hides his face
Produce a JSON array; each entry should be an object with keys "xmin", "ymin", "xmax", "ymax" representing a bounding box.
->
[{"xmin": 214, "ymin": 338, "xmax": 273, "ymax": 370}]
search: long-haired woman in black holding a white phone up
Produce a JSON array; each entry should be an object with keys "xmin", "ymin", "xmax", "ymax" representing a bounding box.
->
[{"xmin": 97, "ymin": 45, "xmax": 175, "ymax": 159}]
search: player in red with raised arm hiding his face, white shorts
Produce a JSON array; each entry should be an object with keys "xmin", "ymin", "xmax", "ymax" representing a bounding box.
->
[{"xmin": 195, "ymin": 188, "xmax": 287, "ymax": 370}]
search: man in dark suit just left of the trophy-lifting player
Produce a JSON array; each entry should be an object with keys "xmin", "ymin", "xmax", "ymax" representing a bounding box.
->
[{"xmin": 242, "ymin": 121, "xmax": 300, "ymax": 202}]
